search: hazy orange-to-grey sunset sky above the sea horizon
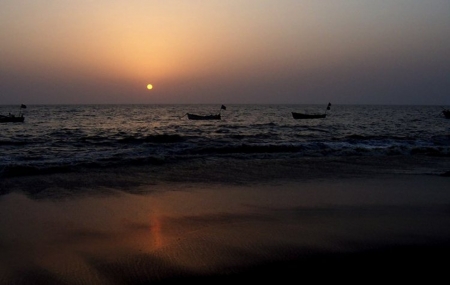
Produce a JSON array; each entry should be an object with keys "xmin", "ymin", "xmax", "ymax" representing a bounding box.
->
[{"xmin": 0, "ymin": 0, "xmax": 450, "ymax": 106}]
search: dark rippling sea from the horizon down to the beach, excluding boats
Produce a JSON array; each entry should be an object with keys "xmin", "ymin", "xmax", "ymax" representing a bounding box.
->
[{"xmin": 0, "ymin": 104, "xmax": 450, "ymax": 178}]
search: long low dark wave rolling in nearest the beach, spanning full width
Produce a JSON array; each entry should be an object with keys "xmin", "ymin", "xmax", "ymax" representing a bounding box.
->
[{"xmin": 0, "ymin": 144, "xmax": 450, "ymax": 178}]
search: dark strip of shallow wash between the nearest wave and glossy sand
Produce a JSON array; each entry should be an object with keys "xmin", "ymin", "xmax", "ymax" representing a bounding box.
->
[{"xmin": 0, "ymin": 156, "xmax": 450, "ymax": 194}]
